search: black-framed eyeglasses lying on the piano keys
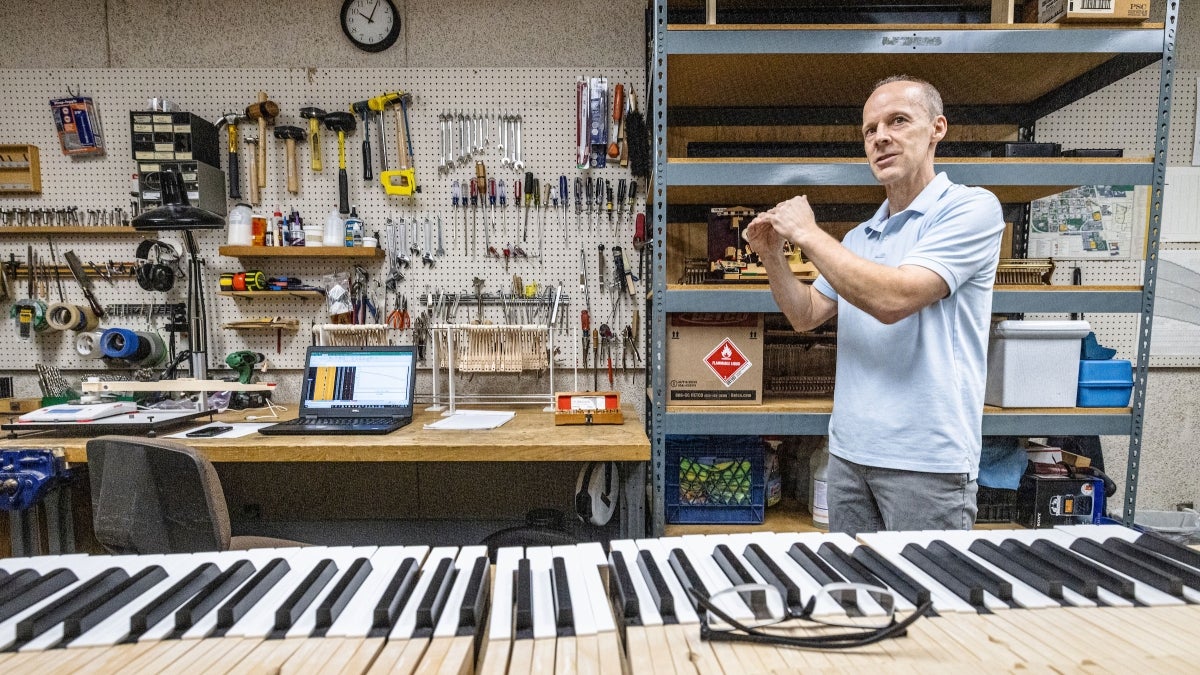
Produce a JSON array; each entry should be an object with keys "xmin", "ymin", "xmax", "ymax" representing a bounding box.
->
[{"xmin": 688, "ymin": 584, "xmax": 932, "ymax": 649}]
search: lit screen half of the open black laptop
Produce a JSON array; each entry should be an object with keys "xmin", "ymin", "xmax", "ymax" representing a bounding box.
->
[{"xmin": 301, "ymin": 345, "xmax": 416, "ymax": 416}]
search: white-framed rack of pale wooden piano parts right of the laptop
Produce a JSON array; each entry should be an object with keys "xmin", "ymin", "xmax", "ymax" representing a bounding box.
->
[{"xmin": 428, "ymin": 323, "xmax": 554, "ymax": 413}]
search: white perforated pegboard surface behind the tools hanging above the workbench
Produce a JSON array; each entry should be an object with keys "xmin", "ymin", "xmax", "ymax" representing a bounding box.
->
[{"xmin": 0, "ymin": 67, "xmax": 647, "ymax": 384}]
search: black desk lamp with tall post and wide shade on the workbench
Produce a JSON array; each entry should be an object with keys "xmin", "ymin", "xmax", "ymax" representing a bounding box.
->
[{"xmin": 132, "ymin": 171, "xmax": 224, "ymax": 398}]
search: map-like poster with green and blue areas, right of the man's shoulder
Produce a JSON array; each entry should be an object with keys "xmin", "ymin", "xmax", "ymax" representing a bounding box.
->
[{"xmin": 1030, "ymin": 185, "xmax": 1150, "ymax": 259}]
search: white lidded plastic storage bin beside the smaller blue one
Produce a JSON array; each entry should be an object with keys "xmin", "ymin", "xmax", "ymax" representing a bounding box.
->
[{"xmin": 984, "ymin": 321, "xmax": 1091, "ymax": 407}]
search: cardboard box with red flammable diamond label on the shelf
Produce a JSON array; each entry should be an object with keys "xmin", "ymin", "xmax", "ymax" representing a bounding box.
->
[{"xmin": 667, "ymin": 312, "xmax": 763, "ymax": 406}]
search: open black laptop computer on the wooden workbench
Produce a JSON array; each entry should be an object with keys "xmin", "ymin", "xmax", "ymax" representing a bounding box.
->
[{"xmin": 258, "ymin": 345, "xmax": 416, "ymax": 436}]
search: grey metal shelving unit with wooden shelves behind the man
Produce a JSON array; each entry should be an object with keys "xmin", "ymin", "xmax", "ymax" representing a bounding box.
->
[{"xmin": 647, "ymin": 0, "xmax": 1178, "ymax": 536}]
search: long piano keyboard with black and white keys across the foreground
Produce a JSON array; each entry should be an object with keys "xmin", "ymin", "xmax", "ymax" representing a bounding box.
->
[{"xmin": 0, "ymin": 526, "xmax": 1200, "ymax": 675}]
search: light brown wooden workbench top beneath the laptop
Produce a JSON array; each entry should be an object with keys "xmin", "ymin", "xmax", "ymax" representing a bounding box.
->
[{"xmin": 0, "ymin": 406, "xmax": 650, "ymax": 464}]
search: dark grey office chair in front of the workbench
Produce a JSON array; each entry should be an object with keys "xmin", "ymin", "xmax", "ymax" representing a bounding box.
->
[{"xmin": 88, "ymin": 436, "xmax": 305, "ymax": 555}]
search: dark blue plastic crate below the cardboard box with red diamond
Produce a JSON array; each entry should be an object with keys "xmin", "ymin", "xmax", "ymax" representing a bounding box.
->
[{"xmin": 664, "ymin": 436, "xmax": 766, "ymax": 524}]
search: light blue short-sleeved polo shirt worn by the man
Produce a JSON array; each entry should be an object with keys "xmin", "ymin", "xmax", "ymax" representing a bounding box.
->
[{"xmin": 814, "ymin": 173, "xmax": 1004, "ymax": 479}]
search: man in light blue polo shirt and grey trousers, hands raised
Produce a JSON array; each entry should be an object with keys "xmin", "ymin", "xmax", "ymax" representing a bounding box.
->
[{"xmin": 746, "ymin": 76, "xmax": 1004, "ymax": 534}]
